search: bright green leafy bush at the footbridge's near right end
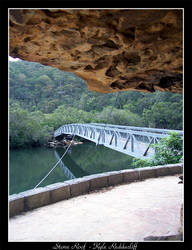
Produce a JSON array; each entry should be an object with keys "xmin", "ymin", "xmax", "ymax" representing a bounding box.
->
[{"xmin": 133, "ymin": 132, "xmax": 183, "ymax": 167}]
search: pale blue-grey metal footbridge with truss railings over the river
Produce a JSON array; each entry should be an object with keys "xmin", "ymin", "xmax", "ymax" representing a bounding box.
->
[{"xmin": 54, "ymin": 123, "xmax": 183, "ymax": 159}]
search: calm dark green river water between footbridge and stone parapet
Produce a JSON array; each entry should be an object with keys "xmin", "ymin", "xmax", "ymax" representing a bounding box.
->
[{"xmin": 9, "ymin": 142, "xmax": 133, "ymax": 194}]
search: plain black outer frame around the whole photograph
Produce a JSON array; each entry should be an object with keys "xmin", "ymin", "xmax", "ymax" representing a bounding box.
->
[{"xmin": 0, "ymin": 0, "xmax": 192, "ymax": 250}]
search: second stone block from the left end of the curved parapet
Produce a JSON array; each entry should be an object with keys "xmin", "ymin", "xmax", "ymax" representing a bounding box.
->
[{"xmin": 24, "ymin": 187, "xmax": 50, "ymax": 211}]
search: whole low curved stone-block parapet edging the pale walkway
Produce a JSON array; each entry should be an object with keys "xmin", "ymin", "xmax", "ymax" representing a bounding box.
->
[{"xmin": 9, "ymin": 163, "xmax": 183, "ymax": 217}]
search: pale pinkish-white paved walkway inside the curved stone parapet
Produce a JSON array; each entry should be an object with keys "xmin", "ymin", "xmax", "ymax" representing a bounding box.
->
[{"xmin": 9, "ymin": 176, "xmax": 183, "ymax": 242}]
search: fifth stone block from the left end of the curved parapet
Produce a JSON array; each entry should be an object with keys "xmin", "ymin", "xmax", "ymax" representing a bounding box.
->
[{"xmin": 90, "ymin": 174, "xmax": 108, "ymax": 191}]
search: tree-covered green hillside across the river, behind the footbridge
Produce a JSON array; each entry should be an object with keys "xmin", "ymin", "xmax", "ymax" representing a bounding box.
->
[{"xmin": 9, "ymin": 60, "xmax": 182, "ymax": 147}]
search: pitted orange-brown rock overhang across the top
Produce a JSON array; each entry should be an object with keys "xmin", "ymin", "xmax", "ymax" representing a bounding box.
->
[{"xmin": 9, "ymin": 9, "xmax": 183, "ymax": 93}]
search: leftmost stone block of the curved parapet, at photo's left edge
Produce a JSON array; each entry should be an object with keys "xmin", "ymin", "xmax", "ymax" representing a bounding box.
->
[{"xmin": 9, "ymin": 195, "xmax": 24, "ymax": 217}]
